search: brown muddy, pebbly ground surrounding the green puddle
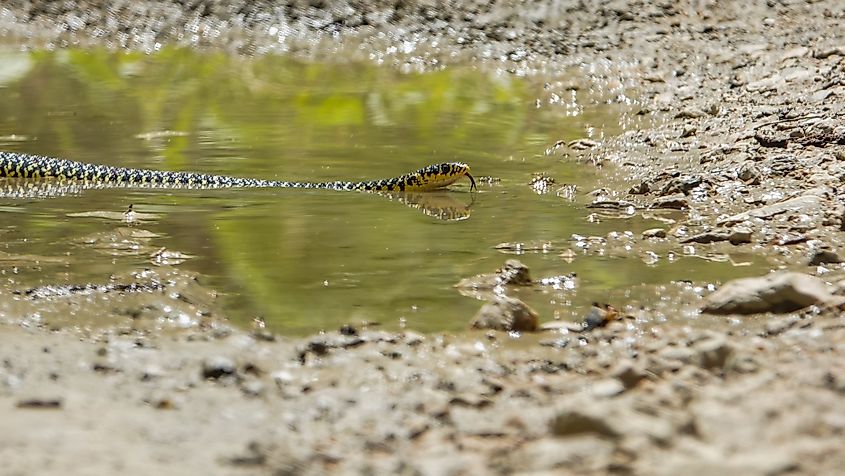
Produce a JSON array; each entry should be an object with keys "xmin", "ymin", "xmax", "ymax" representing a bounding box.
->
[{"xmin": 0, "ymin": 0, "xmax": 845, "ymax": 476}]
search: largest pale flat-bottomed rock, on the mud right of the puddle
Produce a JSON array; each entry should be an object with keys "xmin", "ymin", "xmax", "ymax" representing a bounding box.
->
[{"xmin": 702, "ymin": 272, "xmax": 845, "ymax": 314}]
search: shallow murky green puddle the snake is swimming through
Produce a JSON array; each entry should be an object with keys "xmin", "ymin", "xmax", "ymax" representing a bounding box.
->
[{"xmin": 0, "ymin": 50, "xmax": 764, "ymax": 334}]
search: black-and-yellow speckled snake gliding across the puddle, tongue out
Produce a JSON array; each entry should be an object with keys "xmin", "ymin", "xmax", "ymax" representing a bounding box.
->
[{"xmin": 0, "ymin": 151, "xmax": 476, "ymax": 192}]
